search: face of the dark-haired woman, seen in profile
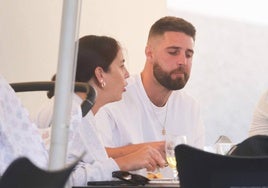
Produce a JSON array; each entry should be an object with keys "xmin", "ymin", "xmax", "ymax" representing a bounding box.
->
[{"xmin": 105, "ymin": 50, "xmax": 129, "ymax": 102}]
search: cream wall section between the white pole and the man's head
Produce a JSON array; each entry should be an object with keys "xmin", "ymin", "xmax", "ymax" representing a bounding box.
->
[{"xmin": 77, "ymin": 0, "xmax": 167, "ymax": 73}]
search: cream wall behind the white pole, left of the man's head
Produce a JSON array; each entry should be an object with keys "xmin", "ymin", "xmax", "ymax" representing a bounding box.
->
[{"xmin": 0, "ymin": 0, "xmax": 167, "ymax": 114}]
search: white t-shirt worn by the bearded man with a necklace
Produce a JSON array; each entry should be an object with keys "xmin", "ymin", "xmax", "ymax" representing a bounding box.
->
[{"xmin": 95, "ymin": 75, "xmax": 204, "ymax": 149}]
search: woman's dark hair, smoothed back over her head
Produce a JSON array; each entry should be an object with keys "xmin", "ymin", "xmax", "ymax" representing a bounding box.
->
[{"xmin": 75, "ymin": 35, "xmax": 121, "ymax": 82}]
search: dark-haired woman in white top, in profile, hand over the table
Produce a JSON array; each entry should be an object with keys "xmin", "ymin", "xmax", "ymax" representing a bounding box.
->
[{"xmin": 34, "ymin": 35, "xmax": 165, "ymax": 185}]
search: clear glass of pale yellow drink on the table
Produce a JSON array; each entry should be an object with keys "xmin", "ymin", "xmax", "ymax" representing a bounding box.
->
[{"xmin": 166, "ymin": 134, "xmax": 186, "ymax": 181}]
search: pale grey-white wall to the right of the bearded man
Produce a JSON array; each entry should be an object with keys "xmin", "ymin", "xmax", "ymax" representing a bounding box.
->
[{"xmin": 169, "ymin": 8, "xmax": 268, "ymax": 145}]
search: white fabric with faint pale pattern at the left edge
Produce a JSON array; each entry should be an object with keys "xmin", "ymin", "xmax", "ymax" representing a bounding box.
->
[{"xmin": 0, "ymin": 75, "xmax": 48, "ymax": 174}]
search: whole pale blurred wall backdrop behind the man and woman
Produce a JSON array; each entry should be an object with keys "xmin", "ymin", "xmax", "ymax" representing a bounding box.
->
[{"xmin": 0, "ymin": 0, "xmax": 268, "ymax": 145}]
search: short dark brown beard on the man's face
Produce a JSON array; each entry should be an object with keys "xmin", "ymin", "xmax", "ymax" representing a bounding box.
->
[{"xmin": 153, "ymin": 62, "xmax": 189, "ymax": 90}]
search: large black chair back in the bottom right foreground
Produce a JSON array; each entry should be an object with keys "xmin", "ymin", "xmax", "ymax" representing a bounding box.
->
[{"xmin": 175, "ymin": 144, "xmax": 268, "ymax": 188}]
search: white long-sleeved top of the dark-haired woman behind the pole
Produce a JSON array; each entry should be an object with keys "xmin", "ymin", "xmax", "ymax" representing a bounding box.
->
[{"xmin": 35, "ymin": 94, "xmax": 119, "ymax": 186}]
